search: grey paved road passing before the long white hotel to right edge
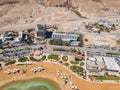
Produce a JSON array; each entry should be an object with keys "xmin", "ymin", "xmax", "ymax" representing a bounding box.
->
[{"xmin": 29, "ymin": 41, "xmax": 120, "ymax": 56}]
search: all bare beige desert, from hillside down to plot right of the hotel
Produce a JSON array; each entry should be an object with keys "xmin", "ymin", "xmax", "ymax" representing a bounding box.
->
[{"xmin": 0, "ymin": 0, "xmax": 120, "ymax": 46}]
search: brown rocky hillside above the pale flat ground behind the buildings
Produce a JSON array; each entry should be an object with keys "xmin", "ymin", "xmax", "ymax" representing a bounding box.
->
[{"xmin": 0, "ymin": 0, "xmax": 120, "ymax": 27}]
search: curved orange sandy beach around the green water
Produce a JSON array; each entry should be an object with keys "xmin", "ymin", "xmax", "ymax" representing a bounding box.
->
[{"xmin": 0, "ymin": 62, "xmax": 120, "ymax": 90}]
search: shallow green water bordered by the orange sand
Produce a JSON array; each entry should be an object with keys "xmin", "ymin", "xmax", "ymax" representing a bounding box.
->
[{"xmin": 0, "ymin": 78, "xmax": 60, "ymax": 90}]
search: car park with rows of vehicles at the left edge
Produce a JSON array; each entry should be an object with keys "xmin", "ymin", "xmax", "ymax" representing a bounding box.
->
[{"xmin": 0, "ymin": 43, "xmax": 32, "ymax": 60}]
